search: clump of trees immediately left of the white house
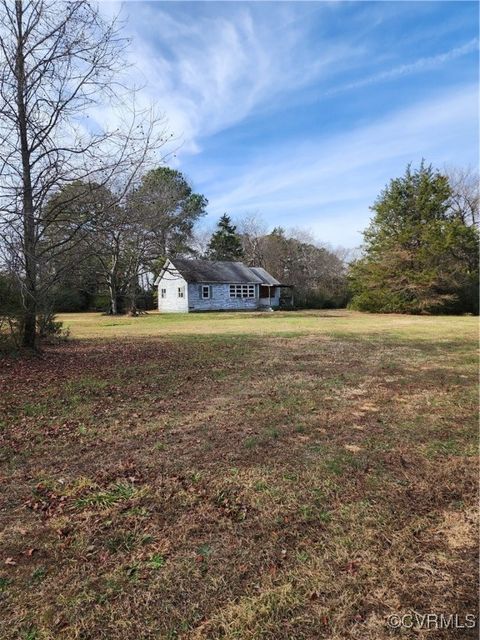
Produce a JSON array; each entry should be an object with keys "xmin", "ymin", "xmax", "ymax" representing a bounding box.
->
[{"xmin": 47, "ymin": 167, "xmax": 207, "ymax": 315}]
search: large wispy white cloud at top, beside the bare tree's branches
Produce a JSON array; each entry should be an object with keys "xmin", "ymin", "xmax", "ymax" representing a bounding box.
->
[{"xmin": 98, "ymin": 3, "xmax": 359, "ymax": 154}]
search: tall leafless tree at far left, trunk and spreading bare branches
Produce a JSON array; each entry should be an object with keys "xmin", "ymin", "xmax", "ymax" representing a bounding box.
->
[{"xmin": 0, "ymin": 0, "xmax": 169, "ymax": 348}]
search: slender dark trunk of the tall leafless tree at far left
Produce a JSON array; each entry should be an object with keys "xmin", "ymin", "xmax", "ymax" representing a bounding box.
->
[{"xmin": 15, "ymin": 0, "xmax": 37, "ymax": 349}]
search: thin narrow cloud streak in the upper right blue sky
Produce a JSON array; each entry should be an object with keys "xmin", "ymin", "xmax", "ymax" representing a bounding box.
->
[{"xmin": 327, "ymin": 38, "xmax": 479, "ymax": 95}]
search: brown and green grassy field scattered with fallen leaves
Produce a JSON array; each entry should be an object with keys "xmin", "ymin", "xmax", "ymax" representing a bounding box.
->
[{"xmin": 0, "ymin": 311, "xmax": 478, "ymax": 640}]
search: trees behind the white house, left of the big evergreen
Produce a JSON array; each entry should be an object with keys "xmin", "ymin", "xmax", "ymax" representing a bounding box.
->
[{"xmin": 0, "ymin": 185, "xmax": 347, "ymax": 318}]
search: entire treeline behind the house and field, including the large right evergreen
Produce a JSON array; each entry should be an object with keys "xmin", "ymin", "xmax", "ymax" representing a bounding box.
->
[{"xmin": 0, "ymin": 163, "xmax": 479, "ymax": 350}]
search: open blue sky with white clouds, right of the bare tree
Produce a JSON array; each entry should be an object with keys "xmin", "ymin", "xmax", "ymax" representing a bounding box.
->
[{"xmin": 104, "ymin": 2, "xmax": 479, "ymax": 247}]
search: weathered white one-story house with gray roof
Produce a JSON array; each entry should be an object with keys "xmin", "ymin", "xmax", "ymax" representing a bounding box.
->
[{"xmin": 155, "ymin": 258, "xmax": 287, "ymax": 313}]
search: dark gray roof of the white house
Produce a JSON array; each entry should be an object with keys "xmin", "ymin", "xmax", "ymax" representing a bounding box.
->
[{"xmin": 171, "ymin": 258, "xmax": 280, "ymax": 285}]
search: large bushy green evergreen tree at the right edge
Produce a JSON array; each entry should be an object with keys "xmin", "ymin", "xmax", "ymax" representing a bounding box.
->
[{"xmin": 349, "ymin": 162, "xmax": 479, "ymax": 313}]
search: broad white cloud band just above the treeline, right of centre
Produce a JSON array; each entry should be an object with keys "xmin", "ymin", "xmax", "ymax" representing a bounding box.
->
[{"xmin": 206, "ymin": 87, "xmax": 478, "ymax": 246}]
